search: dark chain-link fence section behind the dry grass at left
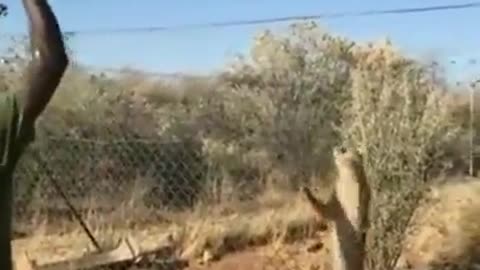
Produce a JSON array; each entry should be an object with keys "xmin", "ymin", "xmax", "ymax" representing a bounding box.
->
[{"xmin": 16, "ymin": 135, "xmax": 208, "ymax": 224}]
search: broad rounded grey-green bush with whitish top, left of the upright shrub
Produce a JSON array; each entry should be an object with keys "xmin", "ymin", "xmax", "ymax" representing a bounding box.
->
[{"xmin": 172, "ymin": 25, "xmax": 352, "ymax": 192}]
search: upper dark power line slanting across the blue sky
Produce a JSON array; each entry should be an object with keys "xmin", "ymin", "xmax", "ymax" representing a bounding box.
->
[{"xmin": 55, "ymin": 1, "xmax": 480, "ymax": 35}]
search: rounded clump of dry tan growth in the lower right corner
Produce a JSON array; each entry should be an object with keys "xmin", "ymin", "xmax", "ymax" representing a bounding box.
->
[{"xmin": 398, "ymin": 178, "xmax": 480, "ymax": 269}]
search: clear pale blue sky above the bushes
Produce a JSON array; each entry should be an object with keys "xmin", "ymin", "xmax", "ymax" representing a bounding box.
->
[{"xmin": 0, "ymin": 0, "xmax": 480, "ymax": 80}]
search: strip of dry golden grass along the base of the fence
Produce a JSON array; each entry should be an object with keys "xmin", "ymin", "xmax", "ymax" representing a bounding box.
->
[{"xmin": 15, "ymin": 187, "xmax": 330, "ymax": 263}]
